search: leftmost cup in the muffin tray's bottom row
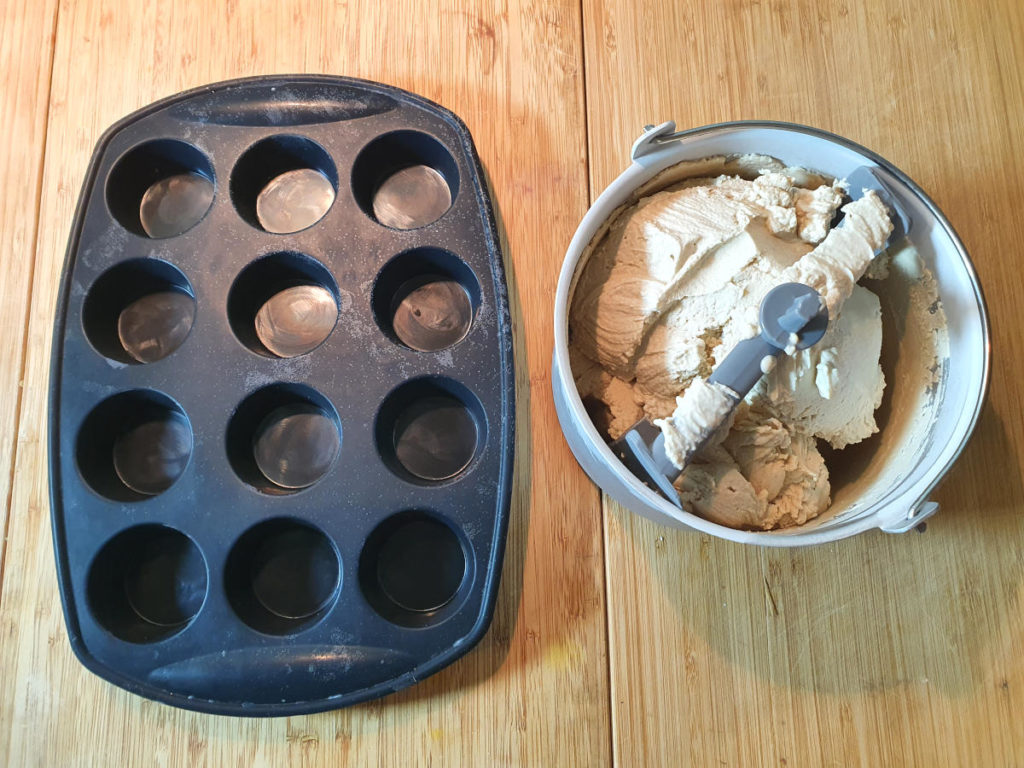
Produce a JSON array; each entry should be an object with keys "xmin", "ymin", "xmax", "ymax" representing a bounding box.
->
[{"xmin": 86, "ymin": 523, "xmax": 208, "ymax": 643}]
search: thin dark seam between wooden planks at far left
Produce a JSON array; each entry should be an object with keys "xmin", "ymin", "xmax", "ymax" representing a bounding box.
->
[{"xmin": 0, "ymin": 3, "xmax": 60, "ymax": 595}]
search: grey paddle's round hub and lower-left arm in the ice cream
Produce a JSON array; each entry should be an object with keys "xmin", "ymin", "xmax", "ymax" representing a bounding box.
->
[{"xmin": 611, "ymin": 283, "xmax": 828, "ymax": 506}]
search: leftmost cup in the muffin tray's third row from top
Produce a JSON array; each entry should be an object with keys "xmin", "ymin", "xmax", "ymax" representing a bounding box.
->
[{"xmin": 76, "ymin": 389, "xmax": 193, "ymax": 502}]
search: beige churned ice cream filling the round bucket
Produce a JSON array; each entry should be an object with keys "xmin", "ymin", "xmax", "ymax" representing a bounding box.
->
[{"xmin": 569, "ymin": 157, "xmax": 925, "ymax": 529}]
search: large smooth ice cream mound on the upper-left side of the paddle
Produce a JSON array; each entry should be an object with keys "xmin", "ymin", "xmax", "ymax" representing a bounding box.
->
[{"xmin": 569, "ymin": 172, "xmax": 839, "ymax": 382}]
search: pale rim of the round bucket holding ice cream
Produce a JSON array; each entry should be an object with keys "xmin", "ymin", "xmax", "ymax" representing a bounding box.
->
[{"xmin": 552, "ymin": 120, "xmax": 991, "ymax": 547}]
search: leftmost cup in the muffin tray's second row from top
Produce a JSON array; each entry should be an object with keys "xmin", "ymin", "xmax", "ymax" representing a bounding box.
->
[{"xmin": 82, "ymin": 259, "xmax": 196, "ymax": 364}]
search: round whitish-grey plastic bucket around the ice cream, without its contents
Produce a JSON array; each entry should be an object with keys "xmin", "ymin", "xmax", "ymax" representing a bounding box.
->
[{"xmin": 552, "ymin": 121, "xmax": 990, "ymax": 547}]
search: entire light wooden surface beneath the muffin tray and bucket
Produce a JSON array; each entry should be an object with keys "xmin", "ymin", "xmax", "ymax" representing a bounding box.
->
[{"xmin": 0, "ymin": 0, "xmax": 1024, "ymax": 767}]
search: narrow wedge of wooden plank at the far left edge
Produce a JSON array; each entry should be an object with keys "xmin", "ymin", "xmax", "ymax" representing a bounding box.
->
[{"xmin": 0, "ymin": 0, "xmax": 57, "ymax": 591}]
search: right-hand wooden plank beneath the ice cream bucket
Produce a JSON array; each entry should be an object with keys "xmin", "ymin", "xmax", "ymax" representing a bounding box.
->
[{"xmin": 584, "ymin": 0, "xmax": 1024, "ymax": 766}]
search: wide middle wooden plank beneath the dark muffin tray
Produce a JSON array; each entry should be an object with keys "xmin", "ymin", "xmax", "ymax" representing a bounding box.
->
[{"xmin": 0, "ymin": 0, "xmax": 610, "ymax": 768}]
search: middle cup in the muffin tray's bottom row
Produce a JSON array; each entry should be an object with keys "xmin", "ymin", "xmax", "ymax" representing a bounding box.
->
[{"xmin": 224, "ymin": 518, "xmax": 341, "ymax": 635}]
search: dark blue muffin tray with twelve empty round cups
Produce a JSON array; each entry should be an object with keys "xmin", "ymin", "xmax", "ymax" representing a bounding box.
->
[{"xmin": 49, "ymin": 76, "xmax": 514, "ymax": 715}]
